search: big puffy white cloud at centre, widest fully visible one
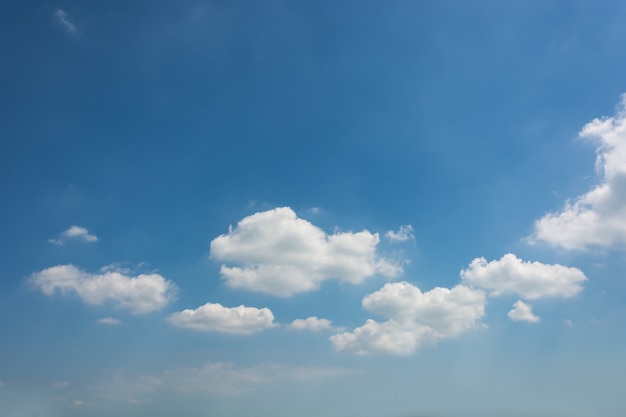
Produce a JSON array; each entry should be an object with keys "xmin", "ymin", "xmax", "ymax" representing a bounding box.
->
[{"xmin": 211, "ymin": 207, "xmax": 402, "ymax": 297}]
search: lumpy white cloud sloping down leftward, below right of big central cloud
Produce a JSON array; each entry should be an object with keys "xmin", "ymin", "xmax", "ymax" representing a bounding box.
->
[{"xmin": 330, "ymin": 282, "xmax": 485, "ymax": 355}]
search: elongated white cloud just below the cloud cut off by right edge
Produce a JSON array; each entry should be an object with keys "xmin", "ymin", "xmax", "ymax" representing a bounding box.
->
[{"xmin": 461, "ymin": 253, "xmax": 587, "ymax": 300}]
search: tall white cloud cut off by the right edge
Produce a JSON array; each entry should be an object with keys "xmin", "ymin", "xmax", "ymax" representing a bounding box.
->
[{"xmin": 529, "ymin": 95, "xmax": 626, "ymax": 250}]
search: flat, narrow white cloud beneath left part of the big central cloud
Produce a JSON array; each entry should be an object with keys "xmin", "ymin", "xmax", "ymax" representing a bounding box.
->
[{"xmin": 168, "ymin": 303, "xmax": 276, "ymax": 334}]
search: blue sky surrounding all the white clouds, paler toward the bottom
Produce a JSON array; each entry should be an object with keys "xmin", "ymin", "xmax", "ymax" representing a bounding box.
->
[{"xmin": 0, "ymin": 1, "xmax": 626, "ymax": 417}]
